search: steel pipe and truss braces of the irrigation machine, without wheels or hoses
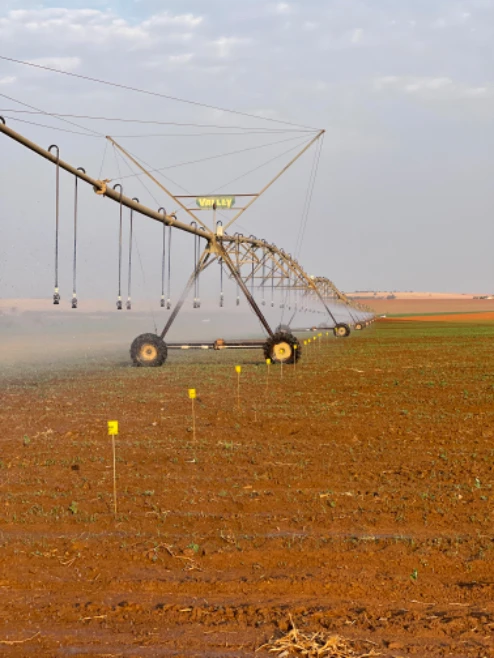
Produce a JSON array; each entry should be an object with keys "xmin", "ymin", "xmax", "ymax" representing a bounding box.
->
[{"xmin": 0, "ymin": 117, "xmax": 369, "ymax": 337}]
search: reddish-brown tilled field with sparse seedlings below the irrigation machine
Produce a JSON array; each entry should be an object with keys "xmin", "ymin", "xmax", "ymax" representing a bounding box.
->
[{"xmin": 0, "ymin": 322, "xmax": 494, "ymax": 658}]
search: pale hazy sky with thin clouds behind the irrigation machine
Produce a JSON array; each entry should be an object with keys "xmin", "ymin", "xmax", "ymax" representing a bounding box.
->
[{"xmin": 0, "ymin": 0, "xmax": 494, "ymax": 298}]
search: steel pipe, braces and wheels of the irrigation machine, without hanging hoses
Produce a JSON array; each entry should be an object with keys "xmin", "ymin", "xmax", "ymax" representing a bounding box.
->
[{"xmin": 0, "ymin": 117, "xmax": 374, "ymax": 365}]
